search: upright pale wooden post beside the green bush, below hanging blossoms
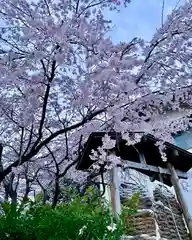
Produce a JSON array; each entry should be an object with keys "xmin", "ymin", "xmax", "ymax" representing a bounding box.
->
[{"xmin": 110, "ymin": 166, "xmax": 121, "ymax": 216}]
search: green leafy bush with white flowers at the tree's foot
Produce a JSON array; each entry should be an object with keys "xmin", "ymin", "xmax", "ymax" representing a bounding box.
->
[{"xmin": 0, "ymin": 190, "xmax": 138, "ymax": 240}]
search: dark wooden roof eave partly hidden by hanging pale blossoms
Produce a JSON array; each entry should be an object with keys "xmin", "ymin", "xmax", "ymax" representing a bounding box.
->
[{"xmin": 77, "ymin": 132, "xmax": 192, "ymax": 178}]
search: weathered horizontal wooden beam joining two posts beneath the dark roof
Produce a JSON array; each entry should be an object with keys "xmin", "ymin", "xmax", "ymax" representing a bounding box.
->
[{"xmin": 123, "ymin": 160, "xmax": 188, "ymax": 179}]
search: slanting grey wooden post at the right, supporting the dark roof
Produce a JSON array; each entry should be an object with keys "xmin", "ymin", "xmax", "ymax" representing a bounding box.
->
[{"xmin": 168, "ymin": 163, "xmax": 192, "ymax": 239}]
